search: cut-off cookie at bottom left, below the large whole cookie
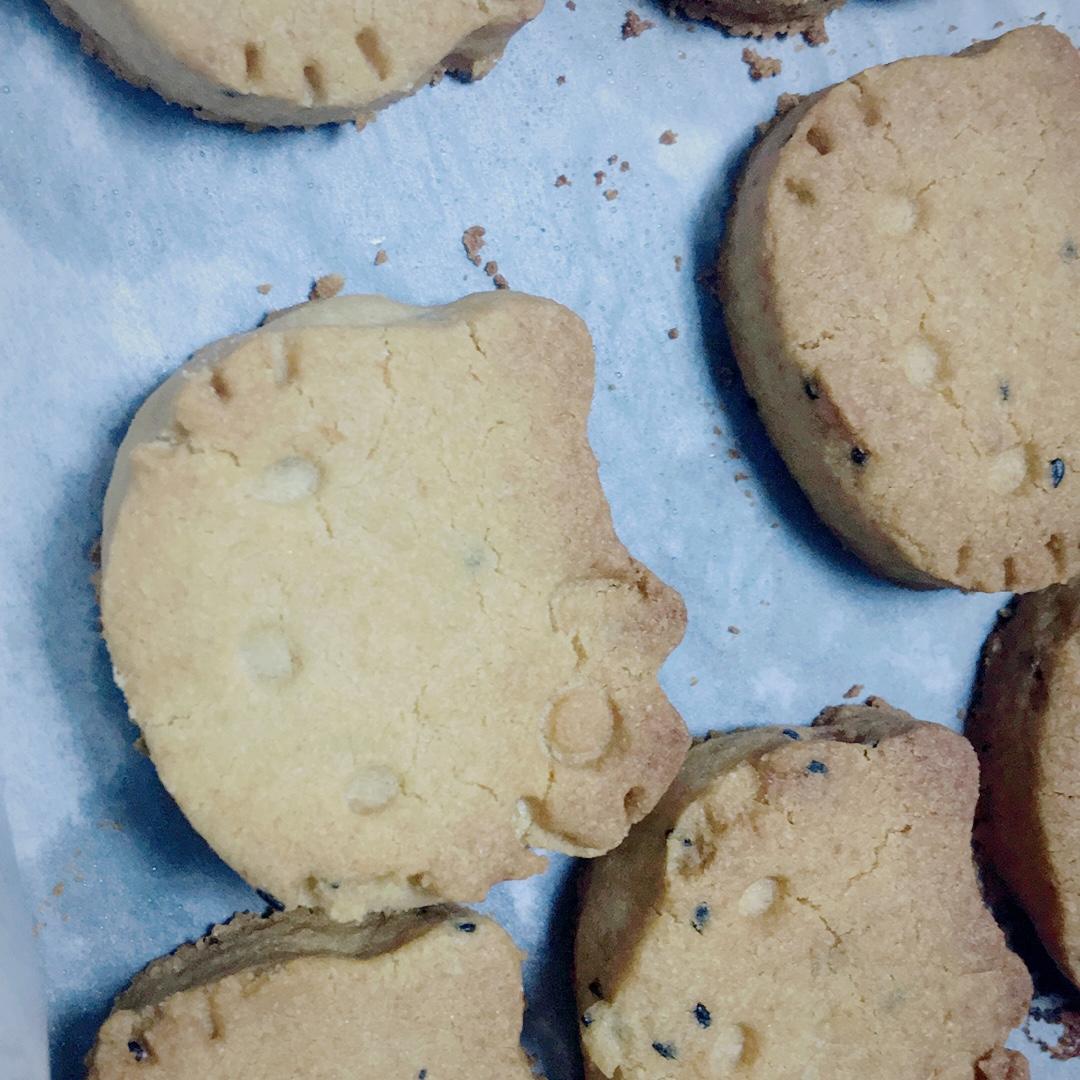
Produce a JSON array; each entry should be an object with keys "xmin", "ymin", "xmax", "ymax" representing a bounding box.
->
[{"xmin": 87, "ymin": 908, "xmax": 532, "ymax": 1080}]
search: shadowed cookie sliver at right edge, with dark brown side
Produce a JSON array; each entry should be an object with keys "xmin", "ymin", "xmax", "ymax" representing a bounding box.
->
[{"xmin": 968, "ymin": 583, "xmax": 1080, "ymax": 985}]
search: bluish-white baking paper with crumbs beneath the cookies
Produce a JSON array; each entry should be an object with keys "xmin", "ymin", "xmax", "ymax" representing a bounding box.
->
[{"xmin": 0, "ymin": 0, "xmax": 1080, "ymax": 1080}]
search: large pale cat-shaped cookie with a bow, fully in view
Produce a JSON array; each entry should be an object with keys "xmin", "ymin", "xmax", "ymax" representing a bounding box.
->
[{"xmin": 100, "ymin": 293, "xmax": 689, "ymax": 919}]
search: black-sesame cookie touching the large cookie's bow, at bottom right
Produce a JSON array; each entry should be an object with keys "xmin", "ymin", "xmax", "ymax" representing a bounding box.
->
[{"xmin": 576, "ymin": 699, "xmax": 1031, "ymax": 1080}]
